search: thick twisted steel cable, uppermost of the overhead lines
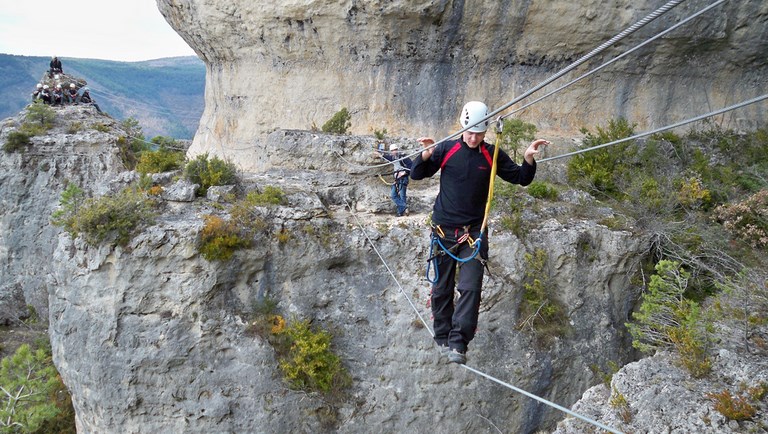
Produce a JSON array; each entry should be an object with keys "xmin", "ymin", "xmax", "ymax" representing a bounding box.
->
[{"xmin": 336, "ymin": 0, "xmax": 685, "ymax": 169}]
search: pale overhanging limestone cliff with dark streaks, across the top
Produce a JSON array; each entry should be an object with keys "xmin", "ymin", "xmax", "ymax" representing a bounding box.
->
[{"xmin": 157, "ymin": 0, "xmax": 768, "ymax": 167}]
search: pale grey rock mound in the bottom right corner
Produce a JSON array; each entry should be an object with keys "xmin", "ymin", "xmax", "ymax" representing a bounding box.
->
[{"xmin": 553, "ymin": 349, "xmax": 768, "ymax": 434}]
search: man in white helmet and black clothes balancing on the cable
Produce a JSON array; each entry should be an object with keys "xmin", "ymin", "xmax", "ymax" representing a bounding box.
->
[{"xmin": 411, "ymin": 101, "xmax": 549, "ymax": 364}]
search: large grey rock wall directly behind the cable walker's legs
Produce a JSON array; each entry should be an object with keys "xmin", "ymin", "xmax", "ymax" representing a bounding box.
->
[{"xmin": 50, "ymin": 173, "xmax": 642, "ymax": 433}]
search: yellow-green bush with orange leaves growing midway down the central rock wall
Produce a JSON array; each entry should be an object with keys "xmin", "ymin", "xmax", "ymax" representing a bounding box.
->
[{"xmin": 279, "ymin": 320, "xmax": 352, "ymax": 393}]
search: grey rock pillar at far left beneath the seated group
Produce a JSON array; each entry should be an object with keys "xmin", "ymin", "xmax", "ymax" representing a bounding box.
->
[{"xmin": 0, "ymin": 105, "xmax": 125, "ymax": 323}]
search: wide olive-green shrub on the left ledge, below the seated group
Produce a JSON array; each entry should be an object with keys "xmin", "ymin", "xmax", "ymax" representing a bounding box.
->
[{"xmin": 52, "ymin": 184, "xmax": 155, "ymax": 246}]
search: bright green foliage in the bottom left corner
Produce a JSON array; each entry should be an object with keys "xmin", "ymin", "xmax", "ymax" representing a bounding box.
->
[{"xmin": 0, "ymin": 344, "xmax": 76, "ymax": 434}]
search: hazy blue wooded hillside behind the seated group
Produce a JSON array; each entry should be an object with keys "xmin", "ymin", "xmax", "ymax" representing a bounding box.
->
[{"xmin": 0, "ymin": 54, "xmax": 205, "ymax": 139}]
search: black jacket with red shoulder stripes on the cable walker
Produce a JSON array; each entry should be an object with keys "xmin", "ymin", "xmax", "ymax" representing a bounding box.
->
[{"xmin": 411, "ymin": 139, "xmax": 536, "ymax": 228}]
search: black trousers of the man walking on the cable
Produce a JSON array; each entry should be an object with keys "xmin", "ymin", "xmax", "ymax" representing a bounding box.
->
[{"xmin": 431, "ymin": 227, "xmax": 488, "ymax": 352}]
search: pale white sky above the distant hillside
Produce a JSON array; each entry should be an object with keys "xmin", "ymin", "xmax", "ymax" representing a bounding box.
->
[{"xmin": 0, "ymin": 0, "xmax": 195, "ymax": 61}]
